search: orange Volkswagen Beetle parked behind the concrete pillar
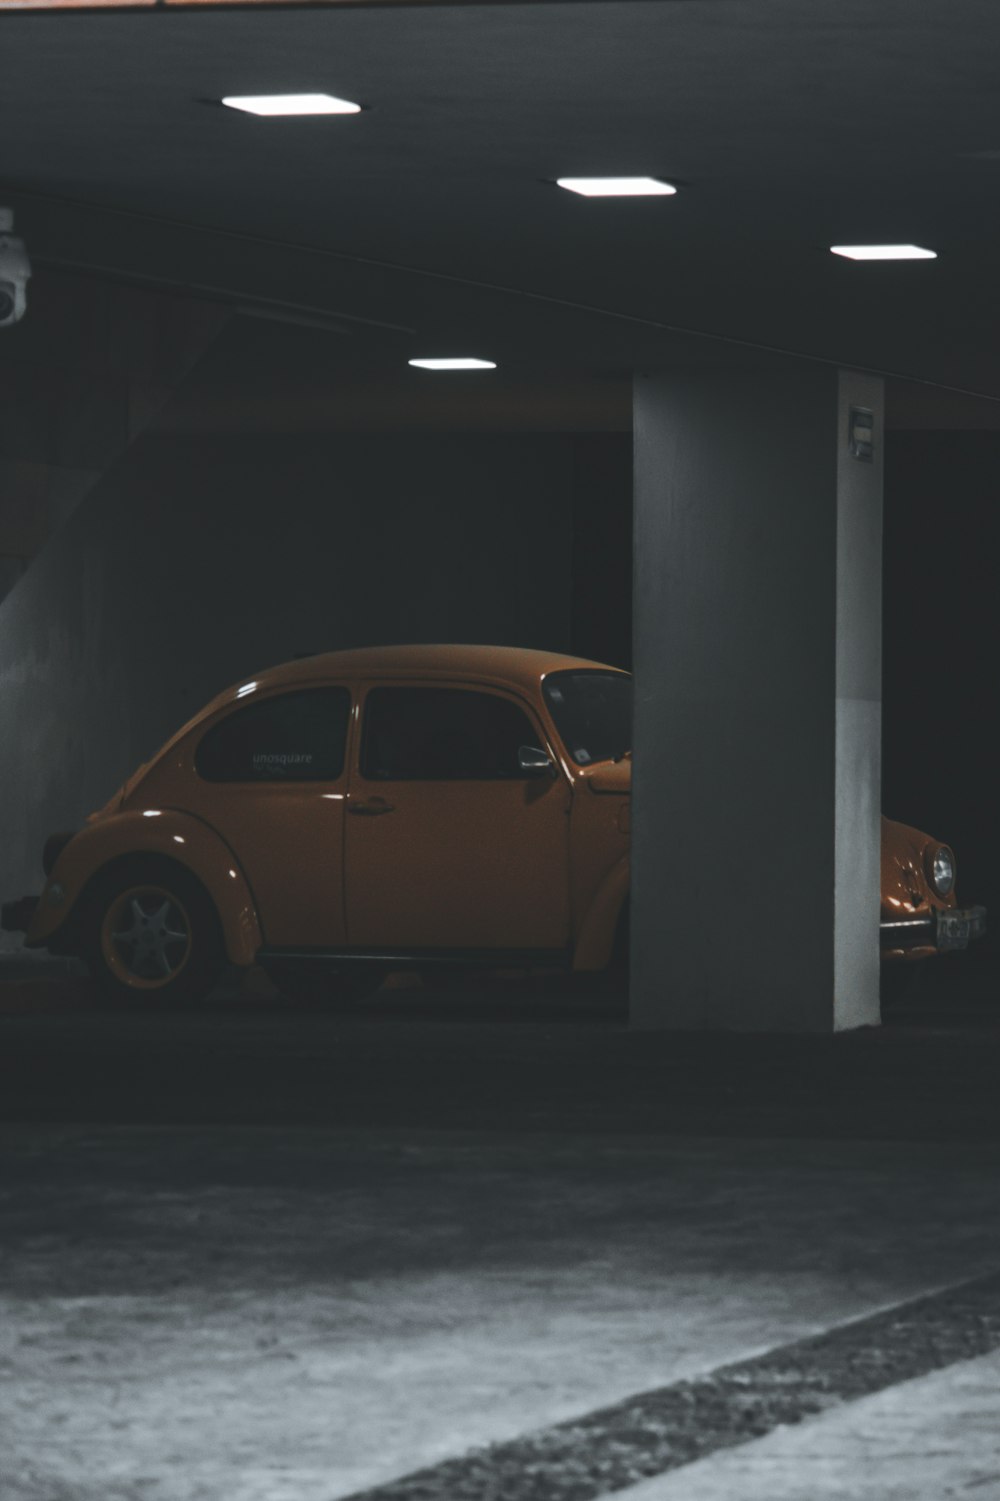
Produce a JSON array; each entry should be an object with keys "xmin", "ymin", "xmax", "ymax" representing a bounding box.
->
[{"xmin": 3, "ymin": 645, "xmax": 985, "ymax": 1000}]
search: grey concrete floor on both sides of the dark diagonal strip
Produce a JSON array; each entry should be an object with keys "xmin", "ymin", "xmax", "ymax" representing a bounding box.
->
[{"xmin": 0, "ymin": 970, "xmax": 1000, "ymax": 1501}]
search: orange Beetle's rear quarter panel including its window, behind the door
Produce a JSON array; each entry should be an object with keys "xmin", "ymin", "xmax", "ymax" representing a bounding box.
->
[{"xmin": 180, "ymin": 684, "xmax": 351, "ymax": 949}]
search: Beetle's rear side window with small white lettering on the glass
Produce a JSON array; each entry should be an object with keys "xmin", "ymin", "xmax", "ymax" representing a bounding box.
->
[{"xmin": 195, "ymin": 687, "xmax": 351, "ymax": 782}]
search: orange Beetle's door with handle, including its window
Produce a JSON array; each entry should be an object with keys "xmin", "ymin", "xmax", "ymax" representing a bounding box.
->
[{"xmin": 345, "ymin": 683, "xmax": 571, "ymax": 949}]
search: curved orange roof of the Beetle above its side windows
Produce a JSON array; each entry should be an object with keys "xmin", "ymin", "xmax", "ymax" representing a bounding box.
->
[{"xmin": 241, "ymin": 644, "xmax": 622, "ymax": 689}]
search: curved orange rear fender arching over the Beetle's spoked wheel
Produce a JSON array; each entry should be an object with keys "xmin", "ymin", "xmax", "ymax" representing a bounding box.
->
[{"xmin": 26, "ymin": 808, "xmax": 263, "ymax": 965}]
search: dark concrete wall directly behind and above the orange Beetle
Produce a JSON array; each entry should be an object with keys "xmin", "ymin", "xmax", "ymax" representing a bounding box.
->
[{"xmin": 0, "ymin": 434, "xmax": 575, "ymax": 918}]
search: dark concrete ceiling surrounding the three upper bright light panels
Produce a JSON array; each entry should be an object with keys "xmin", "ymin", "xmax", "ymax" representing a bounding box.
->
[{"xmin": 0, "ymin": 0, "xmax": 1000, "ymax": 396}]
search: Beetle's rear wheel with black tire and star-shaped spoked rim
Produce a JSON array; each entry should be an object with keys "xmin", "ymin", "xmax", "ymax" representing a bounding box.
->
[{"xmin": 77, "ymin": 856, "xmax": 225, "ymax": 1009}]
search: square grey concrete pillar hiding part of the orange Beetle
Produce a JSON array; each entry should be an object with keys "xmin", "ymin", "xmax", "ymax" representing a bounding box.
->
[{"xmin": 632, "ymin": 360, "xmax": 883, "ymax": 1031}]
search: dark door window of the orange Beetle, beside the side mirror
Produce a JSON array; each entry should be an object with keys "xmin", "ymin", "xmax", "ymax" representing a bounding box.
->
[{"xmin": 360, "ymin": 687, "xmax": 539, "ymax": 782}]
